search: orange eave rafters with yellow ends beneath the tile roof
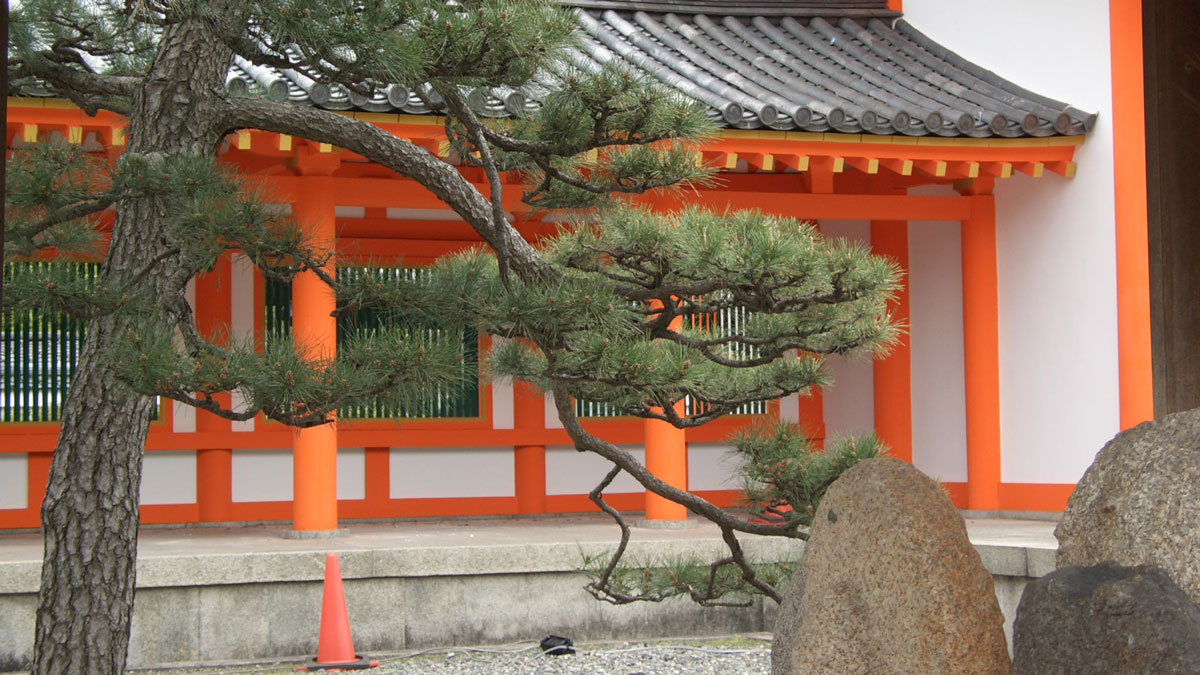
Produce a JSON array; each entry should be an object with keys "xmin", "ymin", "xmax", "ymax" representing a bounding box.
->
[{"xmin": 7, "ymin": 98, "xmax": 1085, "ymax": 223}]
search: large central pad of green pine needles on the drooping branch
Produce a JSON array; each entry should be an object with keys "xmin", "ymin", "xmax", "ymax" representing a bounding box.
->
[{"xmin": 432, "ymin": 208, "xmax": 898, "ymax": 426}]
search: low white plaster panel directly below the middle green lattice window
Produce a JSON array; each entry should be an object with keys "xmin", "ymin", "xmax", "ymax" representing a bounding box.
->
[{"xmin": 390, "ymin": 447, "xmax": 516, "ymax": 500}]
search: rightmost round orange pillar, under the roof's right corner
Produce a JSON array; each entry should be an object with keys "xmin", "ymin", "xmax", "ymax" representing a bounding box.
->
[{"xmin": 962, "ymin": 195, "xmax": 1000, "ymax": 510}]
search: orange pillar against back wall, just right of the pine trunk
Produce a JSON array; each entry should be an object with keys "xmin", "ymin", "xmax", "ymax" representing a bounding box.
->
[{"xmin": 196, "ymin": 255, "xmax": 233, "ymax": 522}]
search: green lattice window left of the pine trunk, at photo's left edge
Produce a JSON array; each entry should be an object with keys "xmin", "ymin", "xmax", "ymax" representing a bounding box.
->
[{"xmin": 0, "ymin": 262, "xmax": 100, "ymax": 422}]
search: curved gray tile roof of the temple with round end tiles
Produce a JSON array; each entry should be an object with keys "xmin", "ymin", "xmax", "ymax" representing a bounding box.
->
[{"xmin": 220, "ymin": 8, "xmax": 1096, "ymax": 137}]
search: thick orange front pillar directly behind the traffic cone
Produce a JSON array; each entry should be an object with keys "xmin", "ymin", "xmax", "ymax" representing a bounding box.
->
[{"xmin": 292, "ymin": 177, "xmax": 337, "ymax": 532}]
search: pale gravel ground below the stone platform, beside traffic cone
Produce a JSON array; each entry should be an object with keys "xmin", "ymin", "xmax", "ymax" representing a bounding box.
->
[{"xmin": 129, "ymin": 637, "xmax": 770, "ymax": 675}]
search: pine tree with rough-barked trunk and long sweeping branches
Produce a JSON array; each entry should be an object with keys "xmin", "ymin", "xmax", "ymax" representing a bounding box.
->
[{"xmin": 5, "ymin": 0, "xmax": 896, "ymax": 673}]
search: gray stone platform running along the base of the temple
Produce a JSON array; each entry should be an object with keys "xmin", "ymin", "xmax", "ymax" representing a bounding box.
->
[{"xmin": 0, "ymin": 514, "xmax": 1057, "ymax": 670}]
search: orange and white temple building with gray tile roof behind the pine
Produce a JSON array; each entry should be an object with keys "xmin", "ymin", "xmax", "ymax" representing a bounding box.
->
[{"xmin": 0, "ymin": 0, "xmax": 1161, "ymax": 528}]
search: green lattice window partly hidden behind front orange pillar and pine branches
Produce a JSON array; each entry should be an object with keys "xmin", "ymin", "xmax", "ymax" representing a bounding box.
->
[{"xmin": 263, "ymin": 267, "xmax": 479, "ymax": 419}]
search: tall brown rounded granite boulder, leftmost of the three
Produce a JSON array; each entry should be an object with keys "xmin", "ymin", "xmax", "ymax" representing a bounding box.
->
[{"xmin": 772, "ymin": 458, "xmax": 1010, "ymax": 675}]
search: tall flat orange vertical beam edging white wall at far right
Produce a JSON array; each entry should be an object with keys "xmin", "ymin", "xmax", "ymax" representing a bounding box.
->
[{"xmin": 1104, "ymin": 0, "xmax": 1154, "ymax": 429}]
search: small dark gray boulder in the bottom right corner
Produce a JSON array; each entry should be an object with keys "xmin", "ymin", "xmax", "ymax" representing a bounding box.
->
[{"xmin": 1013, "ymin": 562, "xmax": 1200, "ymax": 675}]
